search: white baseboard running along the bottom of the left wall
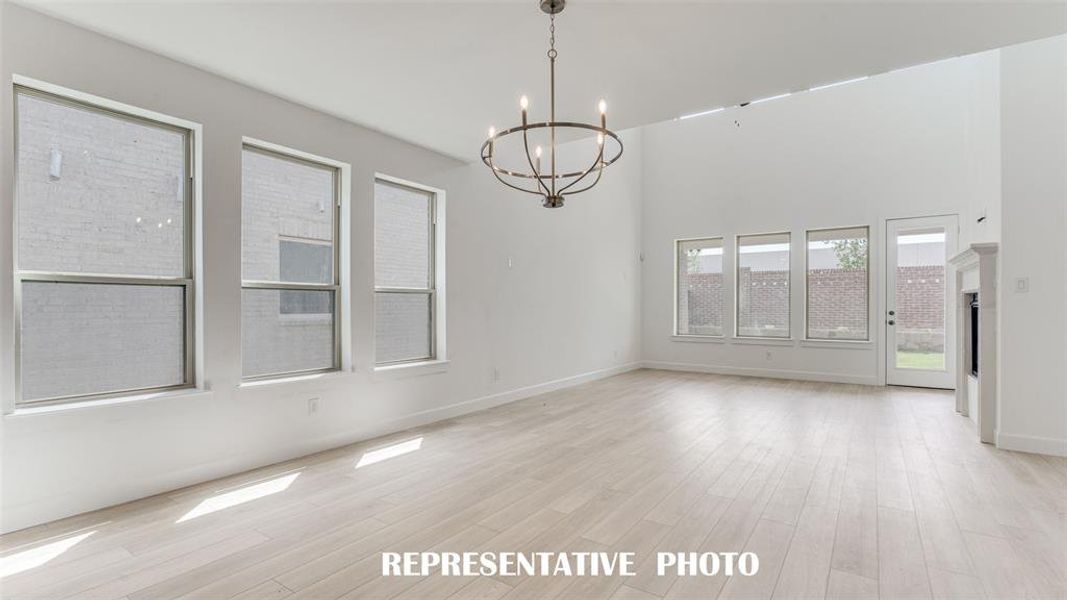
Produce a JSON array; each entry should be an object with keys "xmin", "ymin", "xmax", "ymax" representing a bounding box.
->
[{"xmin": 0, "ymin": 362, "xmax": 640, "ymax": 533}]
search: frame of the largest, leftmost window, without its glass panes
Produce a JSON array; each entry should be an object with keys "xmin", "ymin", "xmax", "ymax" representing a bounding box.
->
[{"xmin": 11, "ymin": 81, "xmax": 201, "ymax": 409}]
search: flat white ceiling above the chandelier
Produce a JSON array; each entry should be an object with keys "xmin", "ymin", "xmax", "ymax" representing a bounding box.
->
[{"xmin": 14, "ymin": 0, "xmax": 1067, "ymax": 160}]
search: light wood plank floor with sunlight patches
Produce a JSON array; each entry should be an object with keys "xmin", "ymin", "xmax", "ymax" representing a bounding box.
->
[{"xmin": 0, "ymin": 370, "xmax": 1067, "ymax": 600}]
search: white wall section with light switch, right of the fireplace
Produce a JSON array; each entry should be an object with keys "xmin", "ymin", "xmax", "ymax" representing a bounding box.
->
[{"xmin": 997, "ymin": 36, "xmax": 1067, "ymax": 456}]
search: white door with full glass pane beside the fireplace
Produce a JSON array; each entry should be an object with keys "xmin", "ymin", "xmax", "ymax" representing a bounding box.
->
[{"xmin": 885, "ymin": 215, "xmax": 959, "ymax": 389}]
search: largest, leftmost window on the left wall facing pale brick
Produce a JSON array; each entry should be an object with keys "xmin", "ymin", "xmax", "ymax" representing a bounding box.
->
[{"xmin": 15, "ymin": 86, "xmax": 193, "ymax": 405}]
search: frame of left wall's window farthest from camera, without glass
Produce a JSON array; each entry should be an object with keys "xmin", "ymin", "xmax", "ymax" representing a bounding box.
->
[{"xmin": 371, "ymin": 173, "xmax": 447, "ymax": 370}]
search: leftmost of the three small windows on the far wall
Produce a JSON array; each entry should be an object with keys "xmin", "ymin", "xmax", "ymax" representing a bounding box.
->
[{"xmin": 674, "ymin": 238, "xmax": 726, "ymax": 335}]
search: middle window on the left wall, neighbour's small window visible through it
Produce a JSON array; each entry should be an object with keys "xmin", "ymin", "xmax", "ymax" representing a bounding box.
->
[{"xmin": 241, "ymin": 144, "xmax": 340, "ymax": 378}]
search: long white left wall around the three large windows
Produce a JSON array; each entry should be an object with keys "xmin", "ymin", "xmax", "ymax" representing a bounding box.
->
[{"xmin": 0, "ymin": 3, "xmax": 641, "ymax": 531}]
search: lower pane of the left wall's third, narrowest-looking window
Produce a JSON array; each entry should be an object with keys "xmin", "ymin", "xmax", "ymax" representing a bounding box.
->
[{"xmin": 375, "ymin": 291, "xmax": 432, "ymax": 363}]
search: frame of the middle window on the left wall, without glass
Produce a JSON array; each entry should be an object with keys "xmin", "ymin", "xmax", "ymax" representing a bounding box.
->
[{"xmin": 238, "ymin": 138, "xmax": 349, "ymax": 383}]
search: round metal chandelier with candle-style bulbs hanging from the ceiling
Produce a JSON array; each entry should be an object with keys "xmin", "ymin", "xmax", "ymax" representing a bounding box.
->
[{"xmin": 481, "ymin": 0, "xmax": 622, "ymax": 208}]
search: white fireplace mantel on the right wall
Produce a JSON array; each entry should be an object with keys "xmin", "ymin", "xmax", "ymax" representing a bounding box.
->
[{"xmin": 949, "ymin": 242, "xmax": 998, "ymax": 444}]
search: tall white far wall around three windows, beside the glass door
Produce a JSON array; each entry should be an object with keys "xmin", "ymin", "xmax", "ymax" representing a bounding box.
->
[{"xmin": 642, "ymin": 52, "xmax": 1000, "ymax": 383}]
